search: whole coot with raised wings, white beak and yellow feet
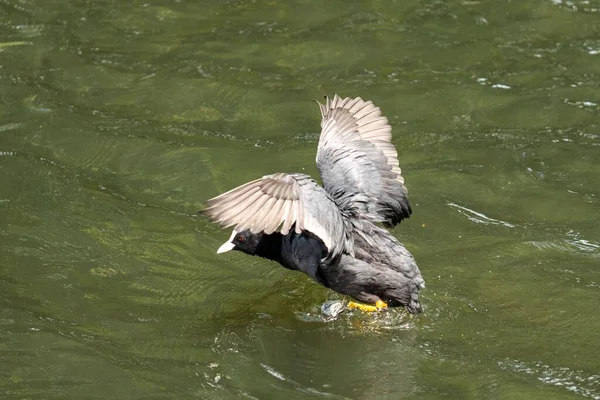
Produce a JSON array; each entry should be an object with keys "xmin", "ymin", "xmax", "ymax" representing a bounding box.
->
[{"xmin": 202, "ymin": 94, "xmax": 425, "ymax": 314}]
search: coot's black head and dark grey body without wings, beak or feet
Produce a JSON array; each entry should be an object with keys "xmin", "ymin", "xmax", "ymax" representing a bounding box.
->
[{"xmin": 232, "ymin": 216, "xmax": 424, "ymax": 314}]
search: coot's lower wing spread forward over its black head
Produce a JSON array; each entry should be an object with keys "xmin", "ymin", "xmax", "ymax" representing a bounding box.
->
[{"xmin": 202, "ymin": 173, "xmax": 352, "ymax": 256}]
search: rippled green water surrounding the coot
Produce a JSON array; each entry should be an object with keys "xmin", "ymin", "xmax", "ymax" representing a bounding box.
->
[{"xmin": 0, "ymin": 0, "xmax": 600, "ymax": 399}]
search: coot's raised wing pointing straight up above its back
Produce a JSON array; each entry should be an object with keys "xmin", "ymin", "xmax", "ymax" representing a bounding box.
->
[{"xmin": 317, "ymin": 95, "xmax": 412, "ymax": 226}]
